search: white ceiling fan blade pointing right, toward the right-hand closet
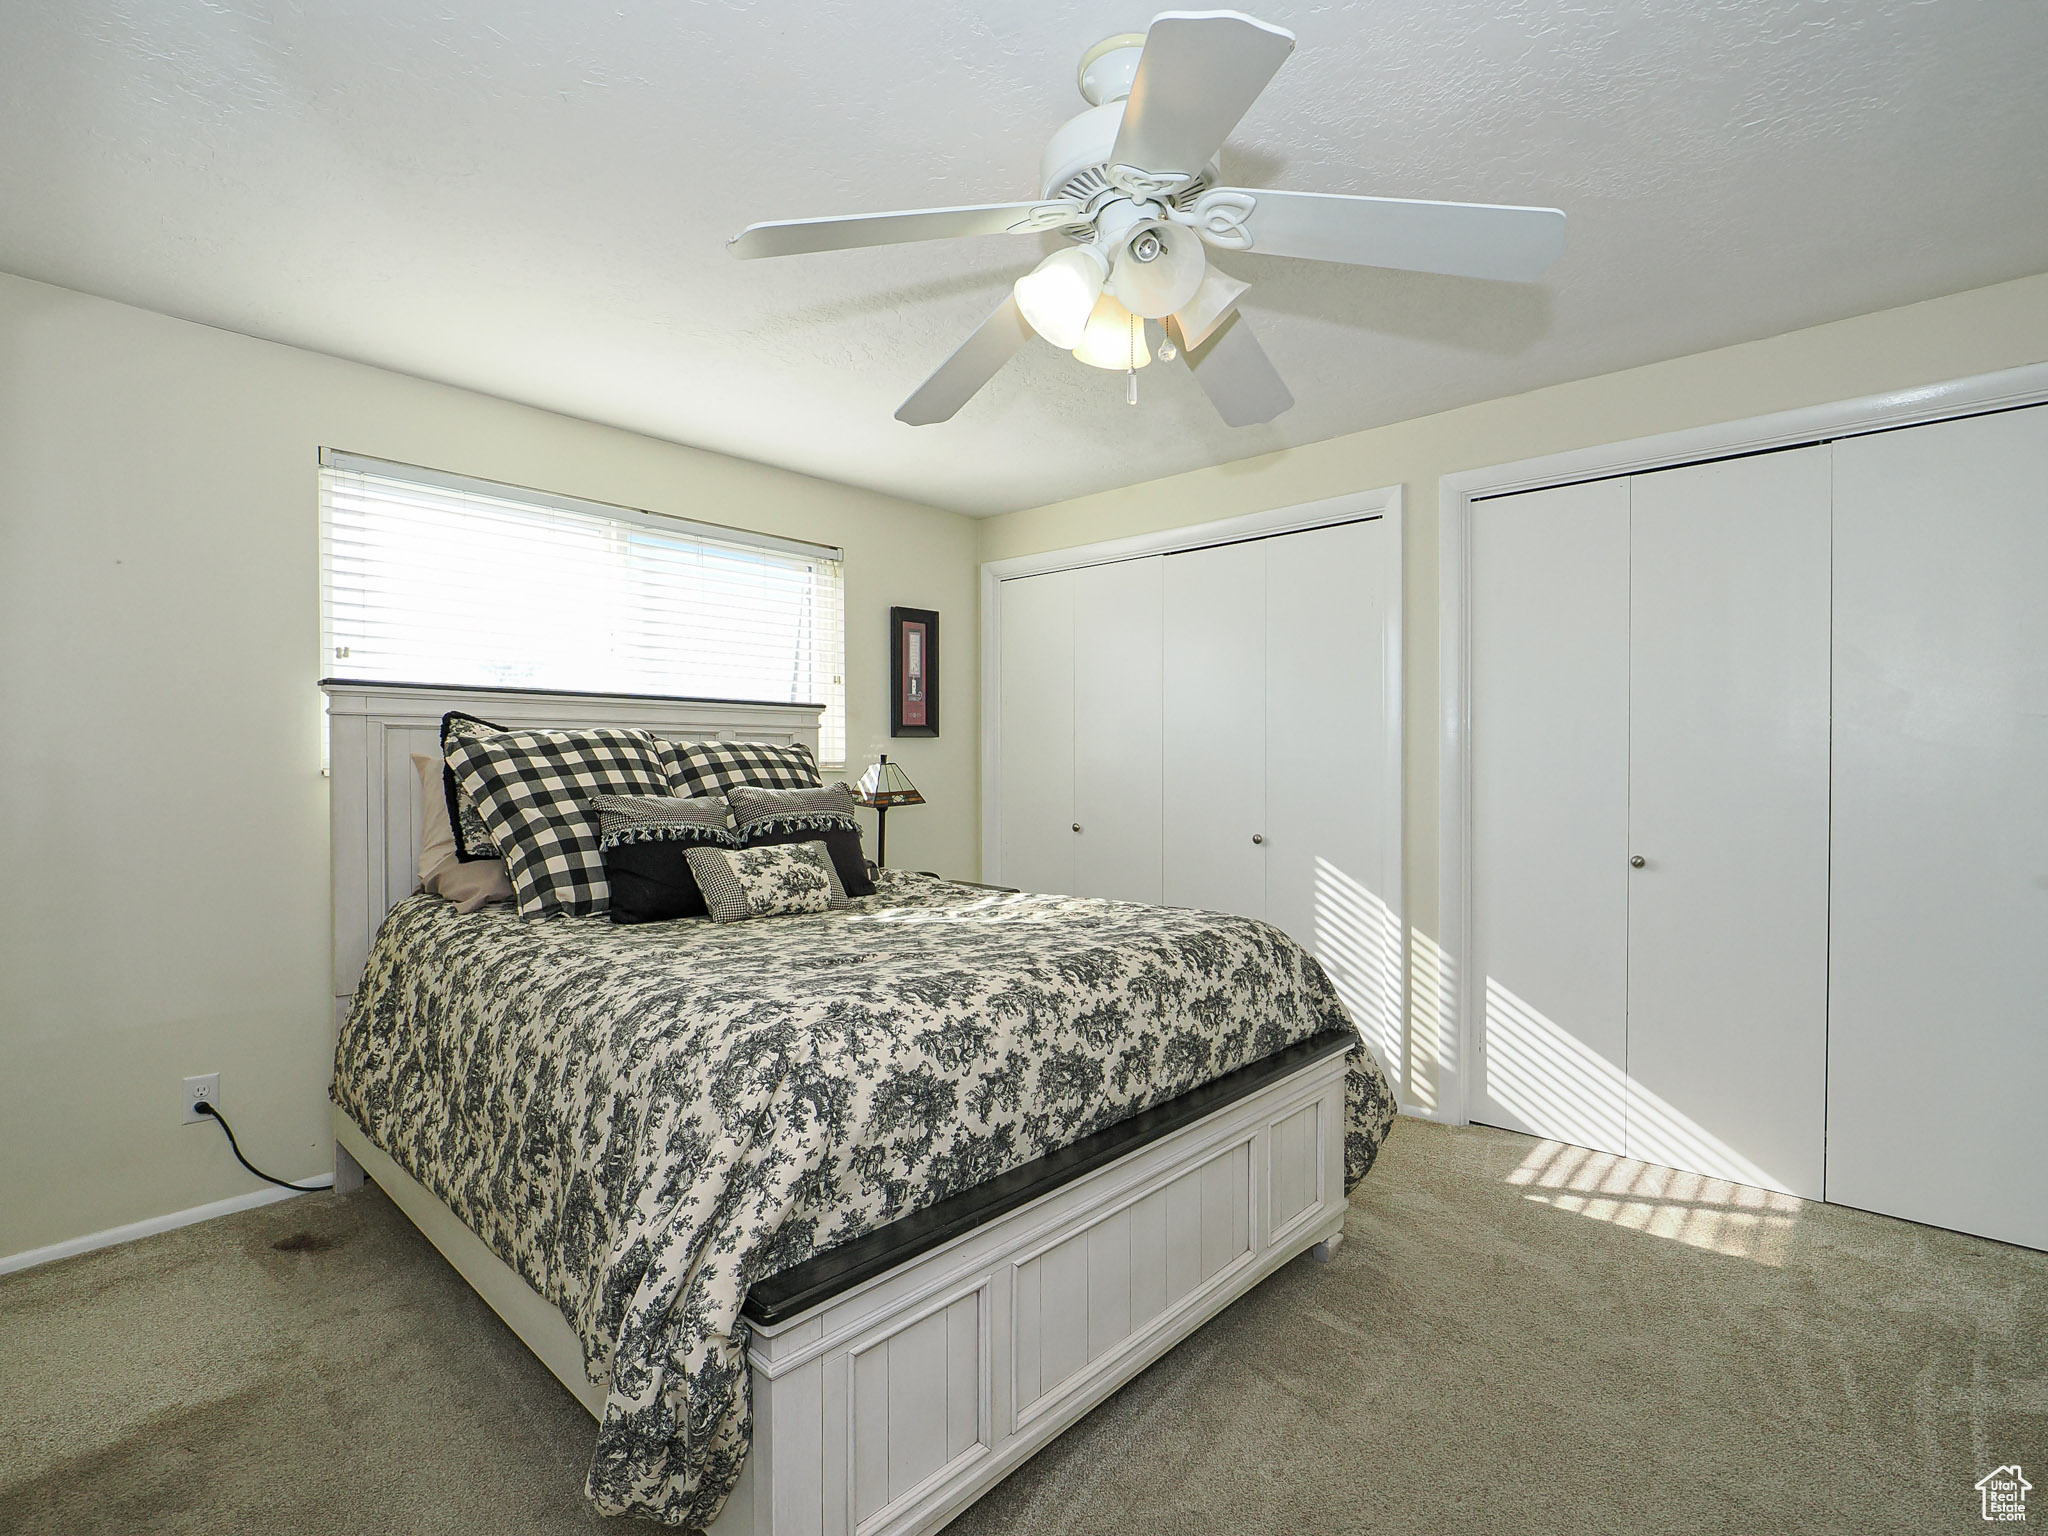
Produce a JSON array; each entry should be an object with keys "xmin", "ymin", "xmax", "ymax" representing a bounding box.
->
[{"xmin": 1194, "ymin": 186, "xmax": 1565, "ymax": 283}]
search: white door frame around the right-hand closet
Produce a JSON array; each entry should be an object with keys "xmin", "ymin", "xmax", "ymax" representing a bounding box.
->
[{"xmin": 1433, "ymin": 362, "xmax": 2048, "ymax": 1124}]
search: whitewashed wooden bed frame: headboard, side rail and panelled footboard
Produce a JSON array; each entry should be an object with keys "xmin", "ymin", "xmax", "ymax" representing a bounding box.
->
[{"xmin": 322, "ymin": 680, "xmax": 1356, "ymax": 1536}]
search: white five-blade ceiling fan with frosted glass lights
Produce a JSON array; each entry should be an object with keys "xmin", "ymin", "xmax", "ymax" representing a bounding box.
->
[{"xmin": 729, "ymin": 10, "xmax": 1565, "ymax": 426}]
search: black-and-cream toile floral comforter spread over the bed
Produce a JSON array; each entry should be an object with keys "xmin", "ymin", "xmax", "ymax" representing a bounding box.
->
[{"xmin": 334, "ymin": 870, "xmax": 1395, "ymax": 1528}]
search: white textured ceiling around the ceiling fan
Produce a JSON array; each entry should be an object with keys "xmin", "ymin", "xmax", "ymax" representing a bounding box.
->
[{"xmin": 0, "ymin": 0, "xmax": 2048, "ymax": 512}]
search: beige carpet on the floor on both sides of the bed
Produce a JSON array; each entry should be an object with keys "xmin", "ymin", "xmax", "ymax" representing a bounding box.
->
[{"xmin": 0, "ymin": 1120, "xmax": 2048, "ymax": 1536}]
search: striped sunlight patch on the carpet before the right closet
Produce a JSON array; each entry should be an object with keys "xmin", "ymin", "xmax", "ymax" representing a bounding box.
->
[{"xmin": 1507, "ymin": 1141, "xmax": 1804, "ymax": 1268}]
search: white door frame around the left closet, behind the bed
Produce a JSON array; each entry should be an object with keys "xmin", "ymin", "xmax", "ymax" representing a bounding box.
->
[{"xmin": 981, "ymin": 485, "xmax": 1409, "ymax": 1073}]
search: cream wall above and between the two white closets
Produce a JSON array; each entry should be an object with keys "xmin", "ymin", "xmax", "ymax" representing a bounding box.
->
[{"xmin": 979, "ymin": 274, "xmax": 2048, "ymax": 1108}]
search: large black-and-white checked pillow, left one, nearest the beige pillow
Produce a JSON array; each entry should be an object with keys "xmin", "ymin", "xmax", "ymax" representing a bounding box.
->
[{"xmin": 449, "ymin": 729, "xmax": 668, "ymax": 918}]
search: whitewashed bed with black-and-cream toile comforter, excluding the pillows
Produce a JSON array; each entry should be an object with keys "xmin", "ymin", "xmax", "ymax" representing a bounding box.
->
[{"xmin": 328, "ymin": 684, "xmax": 1393, "ymax": 1536}]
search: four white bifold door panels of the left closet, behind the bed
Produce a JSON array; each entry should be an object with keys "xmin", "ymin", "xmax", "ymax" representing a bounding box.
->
[{"xmin": 991, "ymin": 518, "xmax": 1405, "ymax": 1073}]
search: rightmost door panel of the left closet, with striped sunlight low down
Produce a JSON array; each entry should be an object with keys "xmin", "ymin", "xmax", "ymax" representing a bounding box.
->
[{"xmin": 1264, "ymin": 520, "xmax": 1403, "ymax": 1071}]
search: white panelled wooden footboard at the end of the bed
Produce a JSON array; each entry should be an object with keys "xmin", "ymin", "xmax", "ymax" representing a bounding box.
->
[{"xmin": 729, "ymin": 1055, "xmax": 1346, "ymax": 1536}]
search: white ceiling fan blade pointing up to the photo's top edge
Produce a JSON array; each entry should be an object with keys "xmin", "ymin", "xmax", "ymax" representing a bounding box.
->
[{"xmin": 1110, "ymin": 10, "xmax": 1294, "ymax": 176}]
